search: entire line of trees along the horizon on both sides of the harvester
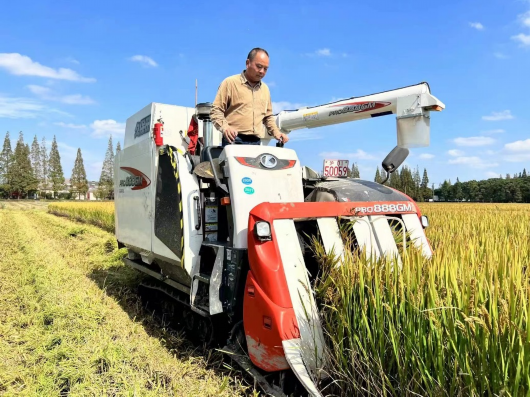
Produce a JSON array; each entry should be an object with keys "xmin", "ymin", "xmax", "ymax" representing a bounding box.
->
[{"xmin": 0, "ymin": 131, "xmax": 530, "ymax": 203}]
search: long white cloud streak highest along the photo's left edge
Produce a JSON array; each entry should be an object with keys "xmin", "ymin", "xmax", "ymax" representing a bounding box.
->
[{"xmin": 0, "ymin": 53, "xmax": 96, "ymax": 83}]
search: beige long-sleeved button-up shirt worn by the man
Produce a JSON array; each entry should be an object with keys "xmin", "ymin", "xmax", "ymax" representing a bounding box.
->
[{"xmin": 210, "ymin": 72, "xmax": 280, "ymax": 138}]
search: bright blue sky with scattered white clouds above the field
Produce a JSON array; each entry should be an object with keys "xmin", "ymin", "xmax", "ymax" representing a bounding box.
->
[{"xmin": 0, "ymin": 0, "xmax": 530, "ymax": 186}]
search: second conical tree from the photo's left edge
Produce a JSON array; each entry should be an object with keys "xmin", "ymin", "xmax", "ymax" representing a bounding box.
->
[{"xmin": 9, "ymin": 132, "xmax": 37, "ymax": 199}]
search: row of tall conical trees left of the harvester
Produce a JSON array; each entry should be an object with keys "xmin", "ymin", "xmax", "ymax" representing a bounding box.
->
[{"xmin": 0, "ymin": 131, "xmax": 121, "ymax": 199}]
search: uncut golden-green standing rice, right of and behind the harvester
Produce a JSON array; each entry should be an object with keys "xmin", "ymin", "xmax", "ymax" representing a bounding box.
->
[{"xmin": 33, "ymin": 203, "xmax": 530, "ymax": 396}]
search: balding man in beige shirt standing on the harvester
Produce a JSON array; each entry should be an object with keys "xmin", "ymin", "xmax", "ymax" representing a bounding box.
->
[{"xmin": 210, "ymin": 48, "xmax": 289, "ymax": 147}]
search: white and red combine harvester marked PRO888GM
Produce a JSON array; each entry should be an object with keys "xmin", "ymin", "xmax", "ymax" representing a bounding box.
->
[{"xmin": 114, "ymin": 83, "xmax": 445, "ymax": 396}]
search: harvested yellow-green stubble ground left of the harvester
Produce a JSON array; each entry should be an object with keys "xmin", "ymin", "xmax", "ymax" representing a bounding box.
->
[{"xmin": 0, "ymin": 209, "xmax": 240, "ymax": 396}]
